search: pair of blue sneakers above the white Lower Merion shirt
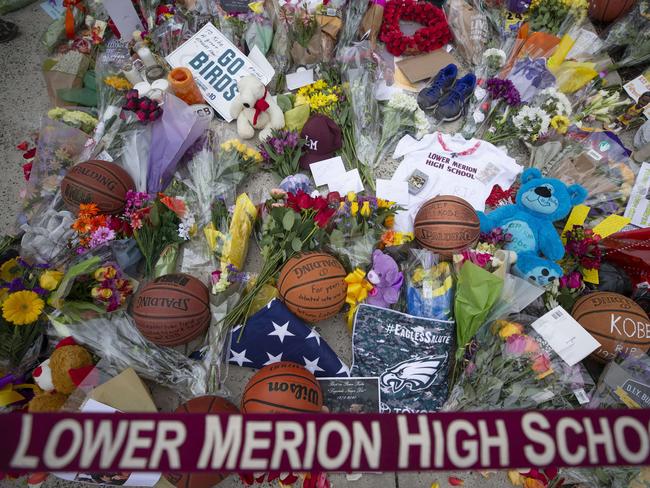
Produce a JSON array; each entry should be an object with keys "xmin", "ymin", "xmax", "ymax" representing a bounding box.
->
[{"xmin": 418, "ymin": 64, "xmax": 476, "ymax": 122}]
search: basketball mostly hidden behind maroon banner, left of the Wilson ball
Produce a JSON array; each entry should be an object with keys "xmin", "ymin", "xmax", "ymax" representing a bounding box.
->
[{"xmin": 165, "ymin": 395, "xmax": 239, "ymax": 488}]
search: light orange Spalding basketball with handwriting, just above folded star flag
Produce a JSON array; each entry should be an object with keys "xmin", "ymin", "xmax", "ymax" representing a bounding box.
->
[{"xmin": 278, "ymin": 252, "xmax": 347, "ymax": 322}]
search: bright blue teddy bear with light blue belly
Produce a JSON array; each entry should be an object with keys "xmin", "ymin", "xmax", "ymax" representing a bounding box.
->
[{"xmin": 477, "ymin": 168, "xmax": 587, "ymax": 286}]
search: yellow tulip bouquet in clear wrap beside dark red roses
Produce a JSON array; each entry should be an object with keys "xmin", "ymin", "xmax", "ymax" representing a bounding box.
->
[{"xmin": 327, "ymin": 192, "xmax": 400, "ymax": 269}]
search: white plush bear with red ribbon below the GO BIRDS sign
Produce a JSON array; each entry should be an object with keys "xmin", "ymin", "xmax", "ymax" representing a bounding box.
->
[{"xmin": 230, "ymin": 75, "xmax": 284, "ymax": 141}]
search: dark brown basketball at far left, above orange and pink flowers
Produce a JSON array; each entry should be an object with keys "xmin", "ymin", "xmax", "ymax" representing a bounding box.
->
[{"xmin": 61, "ymin": 160, "xmax": 135, "ymax": 214}]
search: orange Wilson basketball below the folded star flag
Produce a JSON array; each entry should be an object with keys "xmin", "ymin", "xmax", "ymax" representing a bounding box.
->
[{"xmin": 241, "ymin": 361, "xmax": 323, "ymax": 413}]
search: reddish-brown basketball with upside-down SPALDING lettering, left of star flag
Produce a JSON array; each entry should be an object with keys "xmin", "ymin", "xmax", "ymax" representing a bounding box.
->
[{"xmin": 132, "ymin": 273, "xmax": 211, "ymax": 346}]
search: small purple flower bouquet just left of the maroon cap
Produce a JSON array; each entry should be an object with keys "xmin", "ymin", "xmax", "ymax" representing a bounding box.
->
[{"xmin": 259, "ymin": 129, "xmax": 305, "ymax": 179}]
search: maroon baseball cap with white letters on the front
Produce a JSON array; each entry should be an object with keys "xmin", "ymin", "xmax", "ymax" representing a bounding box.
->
[{"xmin": 300, "ymin": 114, "xmax": 342, "ymax": 169}]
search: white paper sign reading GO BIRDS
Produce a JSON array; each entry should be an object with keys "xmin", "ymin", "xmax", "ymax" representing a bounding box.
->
[{"xmin": 165, "ymin": 23, "xmax": 274, "ymax": 122}]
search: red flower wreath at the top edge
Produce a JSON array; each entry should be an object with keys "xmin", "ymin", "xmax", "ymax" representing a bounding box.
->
[{"xmin": 379, "ymin": 0, "xmax": 452, "ymax": 56}]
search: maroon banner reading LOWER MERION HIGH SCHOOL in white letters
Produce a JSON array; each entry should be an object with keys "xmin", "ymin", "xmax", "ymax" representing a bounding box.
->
[{"xmin": 0, "ymin": 410, "xmax": 650, "ymax": 472}]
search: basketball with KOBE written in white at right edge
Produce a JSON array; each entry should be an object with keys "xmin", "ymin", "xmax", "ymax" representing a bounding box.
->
[{"xmin": 571, "ymin": 291, "xmax": 650, "ymax": 363}]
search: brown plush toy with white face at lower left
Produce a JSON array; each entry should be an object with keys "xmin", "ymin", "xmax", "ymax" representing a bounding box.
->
[{"xmin": 28, "ymin": 337, "xmax": 93, "ymax": 412}]
